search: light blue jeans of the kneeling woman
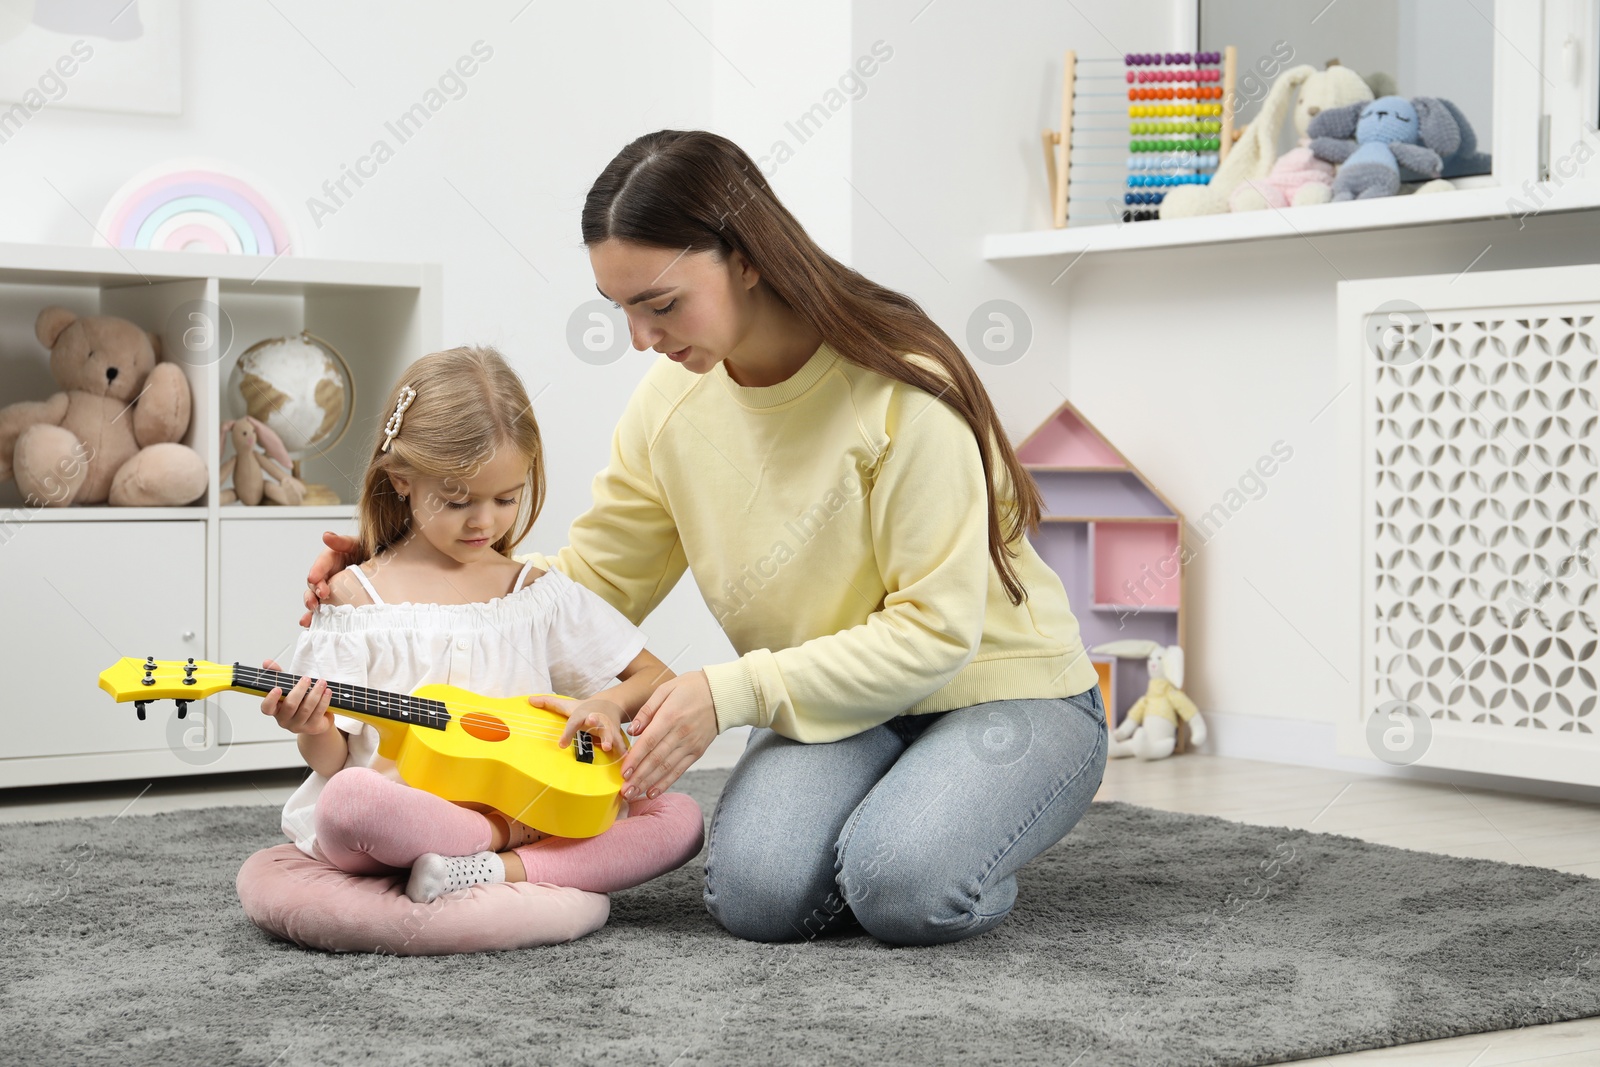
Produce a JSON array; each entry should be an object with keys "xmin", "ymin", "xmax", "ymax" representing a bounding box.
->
[{"xmin": 706, "ymin": 686, "xmax": 1107, "ymax": 945}]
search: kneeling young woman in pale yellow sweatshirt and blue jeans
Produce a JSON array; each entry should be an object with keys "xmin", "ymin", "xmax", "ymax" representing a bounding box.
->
[{"xmin": 307, "ymin": 130, "xmax": 1107, "ymax": 944}]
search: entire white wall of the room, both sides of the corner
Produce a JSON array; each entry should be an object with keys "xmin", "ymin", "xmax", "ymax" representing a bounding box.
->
[{"xmin": 15, "ymin": 0, "xmax": 1600, "ymax": 783}]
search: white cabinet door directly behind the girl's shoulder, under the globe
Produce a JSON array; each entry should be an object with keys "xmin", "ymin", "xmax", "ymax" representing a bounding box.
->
[{"xmin": 218, "ymin": 510, "xmax": 355, "ymax": 744}]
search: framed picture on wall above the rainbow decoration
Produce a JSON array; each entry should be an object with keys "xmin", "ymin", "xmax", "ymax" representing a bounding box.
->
[{"xmin": 0, "ymin": 0, "xmax": 182, "ymax": 117}]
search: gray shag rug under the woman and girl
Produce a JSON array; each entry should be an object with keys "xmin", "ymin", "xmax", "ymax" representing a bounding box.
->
[{"xmin": 0, "ymin": 771, "xmax": 1600, "ymax": 1067}]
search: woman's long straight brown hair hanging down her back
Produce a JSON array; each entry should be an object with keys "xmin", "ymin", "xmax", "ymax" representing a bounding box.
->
[{"xmin": 582, "ymin": 130, "xmax": 1043, "ymax": 605}]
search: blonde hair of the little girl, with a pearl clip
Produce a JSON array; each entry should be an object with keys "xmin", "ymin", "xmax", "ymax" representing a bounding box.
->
[{"xmin": 357, "ymin": 346, "xmax": 544, "ymax": 558}]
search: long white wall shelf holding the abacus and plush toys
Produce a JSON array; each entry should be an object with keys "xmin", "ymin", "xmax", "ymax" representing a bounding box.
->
[{"xmin": 984, "ymin": 182, "xmax": 1600, "ymax": 261}]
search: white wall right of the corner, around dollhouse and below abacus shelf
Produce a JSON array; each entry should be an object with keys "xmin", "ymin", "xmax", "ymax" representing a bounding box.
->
[{"xmin": 853, "ymin": 0, "xmax": 1600, "ymax": 783}]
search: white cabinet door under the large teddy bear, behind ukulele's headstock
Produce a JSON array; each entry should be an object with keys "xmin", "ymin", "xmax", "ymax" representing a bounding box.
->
[{"xmin": 0, "ymin": 524, "xmax": 205, "ymax": 760}]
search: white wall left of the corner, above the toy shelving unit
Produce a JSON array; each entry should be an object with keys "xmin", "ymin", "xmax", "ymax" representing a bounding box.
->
[{"xmin": 0, "ymin": 0, "xmax": 854, "ymax": 684}]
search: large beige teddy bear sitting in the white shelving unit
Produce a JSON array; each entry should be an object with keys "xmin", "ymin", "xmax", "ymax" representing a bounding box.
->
[{"xmin": 0, "ymin": 307, "xmax": 208, "ymax": 507}]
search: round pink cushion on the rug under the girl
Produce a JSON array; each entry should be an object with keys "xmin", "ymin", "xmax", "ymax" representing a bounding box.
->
[{"xmin": 235, "ymin": 841, "xmax": 611, "ymax": 955}]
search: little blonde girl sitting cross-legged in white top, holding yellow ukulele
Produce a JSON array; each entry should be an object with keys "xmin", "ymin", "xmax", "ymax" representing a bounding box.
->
[{"xmin": 261, "ymin": 347, "xmax": 704, "ymax": 902}]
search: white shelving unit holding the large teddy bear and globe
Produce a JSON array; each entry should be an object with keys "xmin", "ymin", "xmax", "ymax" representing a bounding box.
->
[{"xmin": 0, "ymin": 245, "xmax": 443, "ymax": 787}]
